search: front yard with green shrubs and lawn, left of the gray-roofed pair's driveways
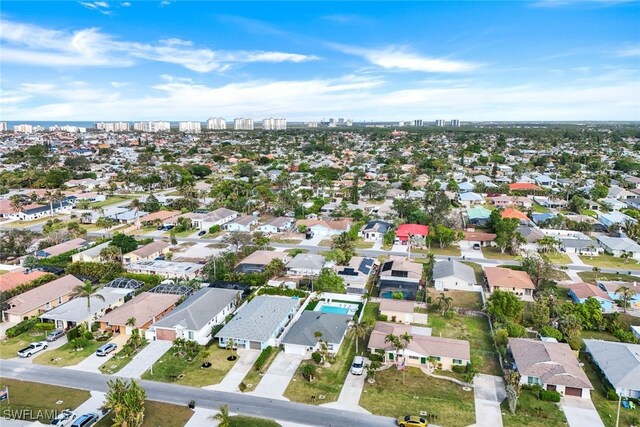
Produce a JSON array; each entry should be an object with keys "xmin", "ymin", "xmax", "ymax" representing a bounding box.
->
[{"xmin": 142, "ymin": 340, "xmax": 237, "ymax": 387}]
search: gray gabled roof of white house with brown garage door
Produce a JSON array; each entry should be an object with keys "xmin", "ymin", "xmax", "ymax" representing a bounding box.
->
[{"xmin": 155, "ymin": 288, "xmax": 239, "ymax": 331}]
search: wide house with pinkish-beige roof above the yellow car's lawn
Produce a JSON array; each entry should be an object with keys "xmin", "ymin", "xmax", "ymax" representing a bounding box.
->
[{"xmin": 367, "ymin": 322, "xmax": 471, "ymax": 371}]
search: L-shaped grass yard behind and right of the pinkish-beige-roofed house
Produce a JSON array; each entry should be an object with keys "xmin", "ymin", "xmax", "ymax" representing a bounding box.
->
[{"xmin": 427, "ymin": 312, "xmax": 502, "ymax": 375}]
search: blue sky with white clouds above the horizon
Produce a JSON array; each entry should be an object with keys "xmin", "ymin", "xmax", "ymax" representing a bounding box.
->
[{"xmin": 0, "ymin": 0, "xmax": 640, "ymax": 121}]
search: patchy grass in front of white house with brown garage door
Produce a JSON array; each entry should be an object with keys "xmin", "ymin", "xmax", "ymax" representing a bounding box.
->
[{"xmin": 142, "ymin": 344, "xmax": 237, "ymax": 387}]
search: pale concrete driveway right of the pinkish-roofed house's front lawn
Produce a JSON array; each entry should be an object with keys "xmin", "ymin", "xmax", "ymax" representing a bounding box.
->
[{"xmin": 473, "ymin": 374, "xmax": 507, "ymax": 427}]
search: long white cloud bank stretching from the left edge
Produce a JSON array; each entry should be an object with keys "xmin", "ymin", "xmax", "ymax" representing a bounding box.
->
[{"xmin": 0, "ymin": 19, "xmax": 319, "ymax": 73}]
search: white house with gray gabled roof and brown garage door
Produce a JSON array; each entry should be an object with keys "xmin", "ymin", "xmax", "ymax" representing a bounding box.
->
[{"xmin": 146, "ymin": 287, "xmax": 241, "ymax": 345}]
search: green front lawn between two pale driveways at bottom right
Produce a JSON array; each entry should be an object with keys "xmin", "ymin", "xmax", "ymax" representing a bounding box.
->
[{"xmin": 501, "ymin": 390, "xmax": 566, "ymax": 427}]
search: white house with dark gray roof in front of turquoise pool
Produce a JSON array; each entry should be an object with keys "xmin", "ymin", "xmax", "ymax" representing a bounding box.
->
[{"xmin": 282, "ymin": 310, "xmax": 353, "ymax": 356}]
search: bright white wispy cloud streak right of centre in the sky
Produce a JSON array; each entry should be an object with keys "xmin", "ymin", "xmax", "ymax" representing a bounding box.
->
[{"xmin": 336, "ymin": 44, "xmax": 481, "ymax": 73}]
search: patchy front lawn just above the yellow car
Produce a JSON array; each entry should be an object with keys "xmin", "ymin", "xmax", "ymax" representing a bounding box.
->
[{"xmin": 360, "ymin": 367, "xmax": 475, "ymax": 427}]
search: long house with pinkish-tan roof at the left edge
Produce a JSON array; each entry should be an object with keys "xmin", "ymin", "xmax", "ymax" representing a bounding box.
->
[{"xmin": 2, "ymin": 274, "xmax": 84, "ymax": 323}]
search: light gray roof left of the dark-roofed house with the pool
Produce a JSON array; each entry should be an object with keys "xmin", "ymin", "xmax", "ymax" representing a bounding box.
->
[{"xmin": 216, "ymin": 295, "xmax": 298, "ymax": 342}]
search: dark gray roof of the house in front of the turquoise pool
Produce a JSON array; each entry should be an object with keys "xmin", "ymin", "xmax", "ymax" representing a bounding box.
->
[{"xmin": 282, "ymin": 311, "xmax": 353, "ymax": 347}]
